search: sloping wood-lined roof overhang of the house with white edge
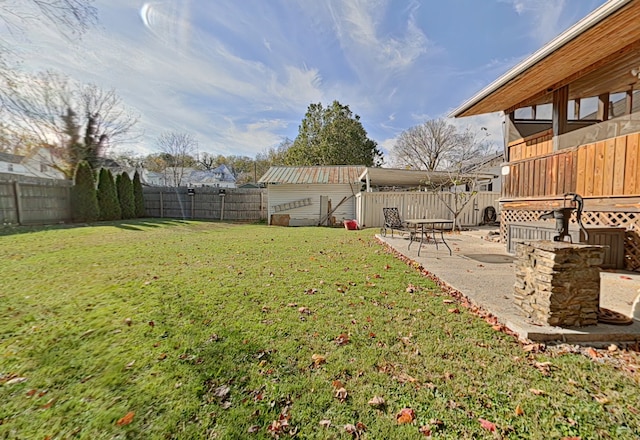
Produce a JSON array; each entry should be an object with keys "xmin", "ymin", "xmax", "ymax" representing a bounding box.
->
[{"xmin": 449, "ymin": 0, "xmax": 640, "ymax": 117}]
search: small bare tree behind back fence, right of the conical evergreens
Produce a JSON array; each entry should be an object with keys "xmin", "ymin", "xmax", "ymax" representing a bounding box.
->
[{"xmin": 156, "ymin": 131, "xmax": 198, "ymax": 186}]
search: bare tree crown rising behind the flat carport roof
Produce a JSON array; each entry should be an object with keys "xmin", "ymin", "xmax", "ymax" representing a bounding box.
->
[{"xmin": 391, "ymin": 118, "xmax": 483, "ymax": 171}]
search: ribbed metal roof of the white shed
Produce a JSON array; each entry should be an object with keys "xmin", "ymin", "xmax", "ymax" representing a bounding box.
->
[{"xmin": 258, "ymin": 165, "xmax": 366, "ymax": 184}]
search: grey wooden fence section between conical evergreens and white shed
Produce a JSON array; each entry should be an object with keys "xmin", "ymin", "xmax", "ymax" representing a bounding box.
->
[{"xmin": 143, "ymin": 187, "xmax": 267, "ymax": 221}]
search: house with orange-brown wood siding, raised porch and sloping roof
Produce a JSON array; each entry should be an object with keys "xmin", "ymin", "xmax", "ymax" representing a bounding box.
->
[{"xmin": 451, "ymin": 0, "xmax": 640, "ymax": 270}]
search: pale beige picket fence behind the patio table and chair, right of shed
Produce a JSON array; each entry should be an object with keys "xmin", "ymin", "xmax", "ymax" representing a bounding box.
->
[{"xmin": 356, "ymin": 191, "xmax": 500, "ymax": 228}]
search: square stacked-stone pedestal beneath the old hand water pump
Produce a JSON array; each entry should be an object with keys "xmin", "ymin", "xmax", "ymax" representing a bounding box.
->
[{"xmin": 514, "ymin": 240, "xmax": 604, "ymax": 327}]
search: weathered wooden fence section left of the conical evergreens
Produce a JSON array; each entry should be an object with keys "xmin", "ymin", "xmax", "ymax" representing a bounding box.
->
[{"xmin": 0, "ymin": 173, "xmax": 73, "ymax": 225}]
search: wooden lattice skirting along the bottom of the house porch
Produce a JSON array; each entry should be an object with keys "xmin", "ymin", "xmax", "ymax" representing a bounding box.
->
[{"xmin": 500, "ymin": 209, "xmax": 640, "ymax": 271}]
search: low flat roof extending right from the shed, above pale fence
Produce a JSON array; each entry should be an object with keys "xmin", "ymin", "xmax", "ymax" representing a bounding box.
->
[{"xmin": 360, "ymin": 168, "xmax": 498, "ymax": 187}]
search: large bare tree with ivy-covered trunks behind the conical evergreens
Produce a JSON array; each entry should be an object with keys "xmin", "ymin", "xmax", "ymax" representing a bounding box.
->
[{"xmin": 1, "ymin": 72, "xmax": 138, "ymax": 177}]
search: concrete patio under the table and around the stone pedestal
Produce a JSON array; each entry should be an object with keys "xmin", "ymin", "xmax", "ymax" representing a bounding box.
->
[{"xmin": 378, "ymin": 227, "xmax": 640, "ymax": 346}]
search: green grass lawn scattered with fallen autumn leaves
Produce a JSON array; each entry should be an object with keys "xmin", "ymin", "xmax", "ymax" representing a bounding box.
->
[{"xmin": 0, "ymin": 220, "xmax": 640, "ymax": 440}]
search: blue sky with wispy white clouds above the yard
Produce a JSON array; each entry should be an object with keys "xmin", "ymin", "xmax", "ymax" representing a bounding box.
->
[{"xmin": 17, "ymin": 0, "xmax": 605, "ymax": 162}]
